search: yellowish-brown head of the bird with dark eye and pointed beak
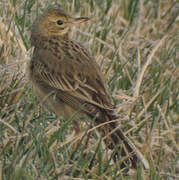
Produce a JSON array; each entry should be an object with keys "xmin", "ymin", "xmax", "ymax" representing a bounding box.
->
[{"xmin": 32, "ymin": 8, "xmax": 89, "ymax": 37}]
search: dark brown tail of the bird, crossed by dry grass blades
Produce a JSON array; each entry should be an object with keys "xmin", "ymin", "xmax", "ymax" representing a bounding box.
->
[{"xmin": 95, "ymin": 115, "xmax": 148, "ymax": 169}]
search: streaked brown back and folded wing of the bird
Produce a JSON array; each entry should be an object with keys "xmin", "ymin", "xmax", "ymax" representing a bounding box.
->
[{"xmin": 31, "ymin": 40, "xmax": 113, "ymax": 109}]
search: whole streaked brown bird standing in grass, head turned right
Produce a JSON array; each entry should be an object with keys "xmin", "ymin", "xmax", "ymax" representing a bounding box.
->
[{"xmin": 29, "ymin": 7, "xmax": 139, "ymax": 168}]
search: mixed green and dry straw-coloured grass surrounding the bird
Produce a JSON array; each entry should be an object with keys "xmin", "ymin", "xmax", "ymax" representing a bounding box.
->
[{"xmin": 0, "ymin": 0, "xmax": 179, "ymax": 180}]
